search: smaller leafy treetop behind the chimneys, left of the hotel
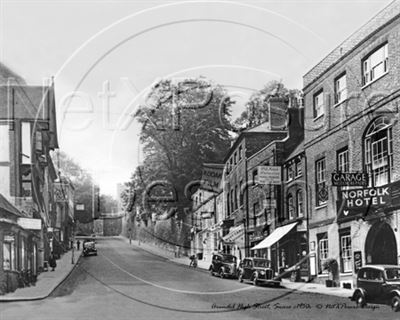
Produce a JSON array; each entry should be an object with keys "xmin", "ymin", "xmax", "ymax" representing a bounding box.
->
[{"xmin": 235, "ymin": 80, "xmax": 300, "ymax": 128}]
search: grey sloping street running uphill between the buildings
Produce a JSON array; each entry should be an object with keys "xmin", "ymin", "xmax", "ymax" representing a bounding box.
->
[{"xmin": 1, "ymin": 238, "xmax": 396, "ymax": 320}]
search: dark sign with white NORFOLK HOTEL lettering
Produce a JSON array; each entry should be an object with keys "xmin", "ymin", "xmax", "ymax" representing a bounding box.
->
[{"xmin": 342, "ymin": 187, "xmax": 390, "ymax": 208}]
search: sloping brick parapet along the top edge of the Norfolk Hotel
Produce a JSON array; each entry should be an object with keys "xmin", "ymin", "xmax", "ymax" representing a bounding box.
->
[{"xmin": 303, "ymin": 0, "xmax": 400, "ymax": 88}]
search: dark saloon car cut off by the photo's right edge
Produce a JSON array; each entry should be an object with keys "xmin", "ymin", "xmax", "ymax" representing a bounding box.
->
[{"xmin": 351, "ymin": 265, "xmax": 400, "ymax": 311}]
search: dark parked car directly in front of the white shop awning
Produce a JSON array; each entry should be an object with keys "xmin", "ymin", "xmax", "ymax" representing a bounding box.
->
[{"xmin": 239, "ymin": 257, "xmax": 281, "ymax": 287}]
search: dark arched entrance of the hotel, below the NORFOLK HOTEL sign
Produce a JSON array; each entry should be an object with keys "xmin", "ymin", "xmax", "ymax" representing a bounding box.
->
[{"xmin": 365, "ymin": 222, "xmax": 397, "ymax": 265}]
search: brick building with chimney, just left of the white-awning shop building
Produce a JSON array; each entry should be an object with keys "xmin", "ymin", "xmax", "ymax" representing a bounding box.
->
[{"xmin": 223, "ymin": 97, "xmax": 287, "ymax": 259}]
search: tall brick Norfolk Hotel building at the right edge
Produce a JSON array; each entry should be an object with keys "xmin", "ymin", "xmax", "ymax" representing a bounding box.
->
[{"xmin": 303, "ymin": 1, "xmax": 400, "ymax": 284}]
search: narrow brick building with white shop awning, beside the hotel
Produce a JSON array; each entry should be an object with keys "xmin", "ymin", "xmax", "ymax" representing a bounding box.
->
[{"xmin": 247, "ymin": 107, "xmax": 308, "ymax": 275}]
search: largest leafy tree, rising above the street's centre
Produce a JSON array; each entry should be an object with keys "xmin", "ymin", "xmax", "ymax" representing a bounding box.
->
[{"xmin": 124, "ymin": 78, "xmax": 231, "ymax": 250}]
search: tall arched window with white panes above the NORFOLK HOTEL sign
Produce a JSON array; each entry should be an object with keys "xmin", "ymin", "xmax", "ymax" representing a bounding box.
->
[{"xmin": 364, "ymin": 117, "xmax": 393, "ymax": 187}]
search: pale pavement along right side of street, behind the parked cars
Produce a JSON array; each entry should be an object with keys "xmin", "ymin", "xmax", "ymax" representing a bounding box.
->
[{"xmin": 121, "ymin": 237, "xmax": 354, "ymax": 298}]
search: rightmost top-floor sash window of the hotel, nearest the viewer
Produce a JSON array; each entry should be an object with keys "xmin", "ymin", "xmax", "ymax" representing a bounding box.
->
[{"xmin": 362, "ymin": 43, "xmax": 388, "ymax": 85}]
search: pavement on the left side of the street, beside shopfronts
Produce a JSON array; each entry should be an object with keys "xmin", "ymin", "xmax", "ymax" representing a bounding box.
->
[{"xmin": 0, "ymin": 250, "xmax": 81, "ymax": 302}]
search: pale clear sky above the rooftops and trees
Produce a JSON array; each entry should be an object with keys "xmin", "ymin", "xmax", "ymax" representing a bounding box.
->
[{"xmin": 0, "ymin": 0, "xmax": 391, "ymax": 196}]
